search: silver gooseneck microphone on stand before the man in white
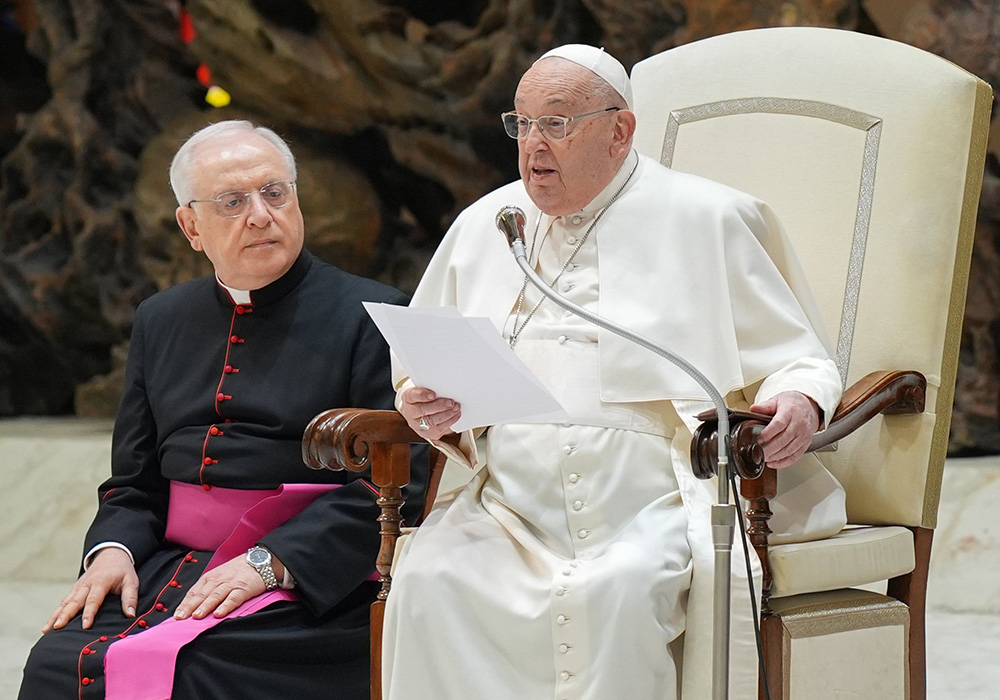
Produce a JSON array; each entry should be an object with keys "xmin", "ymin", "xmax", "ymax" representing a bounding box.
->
[{"xmin": 496, "ymin": 206, "xmax": 736, "ymax": 700}]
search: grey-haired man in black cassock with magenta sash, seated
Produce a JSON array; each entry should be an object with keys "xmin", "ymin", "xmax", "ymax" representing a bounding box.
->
[{"xmin": 18, "ymin": 121, "xmax": 426, "ymax": 700}]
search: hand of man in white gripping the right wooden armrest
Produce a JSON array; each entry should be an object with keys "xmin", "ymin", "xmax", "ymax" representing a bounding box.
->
[{"xmin": 750, "ymin": 391, "xmax": 819, "ymax": 469}]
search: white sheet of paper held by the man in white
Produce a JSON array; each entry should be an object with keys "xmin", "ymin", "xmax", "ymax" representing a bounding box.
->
[{"xmin": 364, "ymin": 302, "xmax": 568, "ymax": 433}]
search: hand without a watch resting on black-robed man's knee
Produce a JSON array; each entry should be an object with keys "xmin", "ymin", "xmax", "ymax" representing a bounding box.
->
[{"xmin": 42, "ymin": 547, "xmax": 139, "ymax": 634}]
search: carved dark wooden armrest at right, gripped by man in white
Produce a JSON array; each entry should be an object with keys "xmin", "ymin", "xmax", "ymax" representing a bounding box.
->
[{"xmin": 691, "ymin": 370, "xmax": 927, "ymax": 479}]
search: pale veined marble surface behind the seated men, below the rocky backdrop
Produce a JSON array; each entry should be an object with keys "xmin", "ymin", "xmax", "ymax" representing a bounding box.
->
[{"xmin": 0, "ymin": 420, "xmax": 1000, "ymax": 700}]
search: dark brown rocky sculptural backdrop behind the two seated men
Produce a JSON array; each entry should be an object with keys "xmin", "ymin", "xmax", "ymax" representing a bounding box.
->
[{"xmin": 0, "ymin": 0, "xmax": 1000, "ymax": 452}]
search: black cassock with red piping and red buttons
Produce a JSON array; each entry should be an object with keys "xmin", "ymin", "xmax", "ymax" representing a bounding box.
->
[{"xmin": 18, "ymin": 251, "xmax": 427, "ymax": 700}]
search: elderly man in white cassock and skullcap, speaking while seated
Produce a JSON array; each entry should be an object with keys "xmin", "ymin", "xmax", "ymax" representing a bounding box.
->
[{"xmin": 383, "ymin": 45, "xmax": 845, "ymax": 700}]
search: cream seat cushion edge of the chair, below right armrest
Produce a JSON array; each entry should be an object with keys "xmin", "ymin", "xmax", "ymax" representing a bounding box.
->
[{"xmin": 768, "ymin": 525, "xmax": 915, "ymax": 598}]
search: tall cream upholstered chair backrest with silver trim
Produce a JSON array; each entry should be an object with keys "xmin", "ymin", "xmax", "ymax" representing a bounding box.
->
[{"xmin": 632, "ymin": 27, "xmax": 992, "ymax": 527}]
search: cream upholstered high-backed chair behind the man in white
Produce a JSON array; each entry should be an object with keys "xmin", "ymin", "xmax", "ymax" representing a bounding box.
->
[{"xmin": 632, "ymin": 27, "xmax": 992, "ymax": 700}]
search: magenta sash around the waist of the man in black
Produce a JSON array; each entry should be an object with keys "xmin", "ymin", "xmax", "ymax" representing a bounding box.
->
[{"xmin": 104, "ymin": 481, "xmax": 339, "ymax": 700}]
